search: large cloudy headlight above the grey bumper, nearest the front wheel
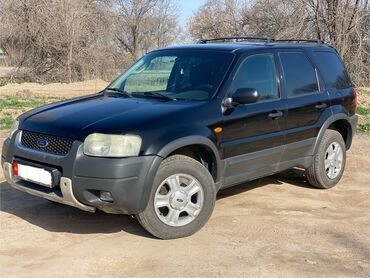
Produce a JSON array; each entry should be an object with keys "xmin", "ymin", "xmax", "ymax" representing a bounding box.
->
[{"xmin": 84, "ymin": 133, "xmax": 141, "ymax": 157}]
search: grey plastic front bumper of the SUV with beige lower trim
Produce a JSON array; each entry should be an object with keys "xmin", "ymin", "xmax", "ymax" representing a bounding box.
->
[{"xmin": 1, "ymin": 131, "xmax": 162, "ymax": 214}]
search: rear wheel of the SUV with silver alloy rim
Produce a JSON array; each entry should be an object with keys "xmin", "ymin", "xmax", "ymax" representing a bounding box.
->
[{"xmin": 306, "ymin": 129, "xmax": 346, "ymax": 189}]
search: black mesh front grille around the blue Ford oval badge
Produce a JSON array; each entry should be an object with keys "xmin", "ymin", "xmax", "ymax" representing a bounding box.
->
[{"xmin": 21, "ymin": 131, "xmax": 73, "ymax": 155}]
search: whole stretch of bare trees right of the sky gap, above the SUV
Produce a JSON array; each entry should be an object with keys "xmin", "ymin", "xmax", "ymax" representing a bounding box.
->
[{"xmin": 188, "ymin": 0, "xmax": 370, "ymax": 86}]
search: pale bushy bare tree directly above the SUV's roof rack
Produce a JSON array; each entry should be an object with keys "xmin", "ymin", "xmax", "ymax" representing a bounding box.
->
[{"xmin": 188, "ymin": 0, "xmax": 309, "ymax": 39}]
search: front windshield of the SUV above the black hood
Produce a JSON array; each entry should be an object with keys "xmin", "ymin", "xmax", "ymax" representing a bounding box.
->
[{"xmin": 108, "ymin": 50, "xmax": 233, "ymax": 100}]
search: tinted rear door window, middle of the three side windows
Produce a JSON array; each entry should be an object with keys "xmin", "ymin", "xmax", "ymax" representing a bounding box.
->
[{"xmin": 279, "ymin": 53, "xmax": 318, "ymax": 97}]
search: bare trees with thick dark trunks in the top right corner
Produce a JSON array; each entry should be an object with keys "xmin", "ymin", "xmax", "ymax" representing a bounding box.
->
[{"xmin": 303, "ymin": 0, "xmax": 370, "ymax": 86}]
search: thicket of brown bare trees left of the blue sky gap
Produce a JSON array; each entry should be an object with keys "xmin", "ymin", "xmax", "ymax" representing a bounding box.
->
[{"xmin": 0, "ymin": 0, "xmax": 178, "ymax": 82}]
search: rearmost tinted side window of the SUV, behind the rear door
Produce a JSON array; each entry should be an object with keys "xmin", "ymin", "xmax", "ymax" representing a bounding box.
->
[{"xmin": 314, "ymin": 51, "xmax": 352, "ymax": 89}]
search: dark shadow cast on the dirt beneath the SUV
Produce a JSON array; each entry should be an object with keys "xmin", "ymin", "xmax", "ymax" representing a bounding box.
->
[{"xmin": 0, "ymin": 169, "xmax": 311, "ymax": 238}]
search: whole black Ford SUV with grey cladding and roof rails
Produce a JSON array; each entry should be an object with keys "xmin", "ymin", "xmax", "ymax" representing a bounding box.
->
[{"xmin": 1, "ymin": 37, "xmax": 357, "ymax": 239}]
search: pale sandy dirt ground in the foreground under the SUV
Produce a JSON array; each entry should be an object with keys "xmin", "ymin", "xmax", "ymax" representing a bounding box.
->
[{"xmin": 0, "ymin": 136, "xmax": 370, "ymax": 277}]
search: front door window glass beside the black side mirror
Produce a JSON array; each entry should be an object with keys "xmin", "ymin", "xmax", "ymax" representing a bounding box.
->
[{"xmin": 231, "ymin": 54, "xmax": 279, "ymax": 100}]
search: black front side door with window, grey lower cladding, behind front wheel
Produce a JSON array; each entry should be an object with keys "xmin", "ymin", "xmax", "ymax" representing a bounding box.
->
[{"xmin": 221, "ymin": 52, "xmax": 285, "ymax": 187}]
